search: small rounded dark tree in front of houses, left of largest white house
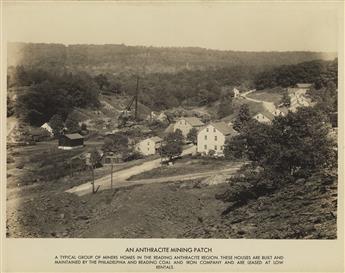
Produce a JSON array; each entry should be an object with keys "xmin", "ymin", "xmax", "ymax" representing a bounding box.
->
[{"xmin": 162, "ymin": 130, "xmax": 183, "ymax": 161}]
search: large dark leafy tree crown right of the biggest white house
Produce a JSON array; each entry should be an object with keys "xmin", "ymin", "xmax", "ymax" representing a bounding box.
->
[{"xmin": 229, "ymin": 107, "xmax": 336, "ymax": 177}]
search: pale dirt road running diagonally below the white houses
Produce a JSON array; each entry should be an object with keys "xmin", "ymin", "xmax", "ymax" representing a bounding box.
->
[{"xmin": 66, "ymin": 146, "xmax": 196, "ymax": 196}]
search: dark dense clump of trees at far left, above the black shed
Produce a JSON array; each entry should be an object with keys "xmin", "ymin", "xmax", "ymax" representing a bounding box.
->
[{"xmin": 13, "ymin": 66, "xmax": 99, "ymax": 125}]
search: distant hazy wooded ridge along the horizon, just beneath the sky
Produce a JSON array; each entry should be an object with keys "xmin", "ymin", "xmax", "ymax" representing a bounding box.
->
[{"xmin": 7, "ymin": 41, "xmax": 337, "ymax": 75}]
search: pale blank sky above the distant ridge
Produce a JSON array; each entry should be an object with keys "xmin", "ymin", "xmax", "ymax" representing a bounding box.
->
[{"xmin": 3, "ymin": 1, "xmax": 340, "ymax": 52}]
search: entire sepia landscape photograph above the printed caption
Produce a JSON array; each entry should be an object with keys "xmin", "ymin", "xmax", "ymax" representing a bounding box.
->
[{"xmin": 5, "ymin": 3, "xmax": 340, "ymax": 240}]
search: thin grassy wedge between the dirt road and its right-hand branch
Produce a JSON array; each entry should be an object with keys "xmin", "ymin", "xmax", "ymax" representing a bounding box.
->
[{"xmin": 128, "ymin": 155, "xmax": 238, "ymax": 180}]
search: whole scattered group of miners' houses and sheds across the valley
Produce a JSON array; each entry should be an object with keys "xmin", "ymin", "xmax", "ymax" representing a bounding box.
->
[{"xmin": 41, "ymin": 84, "xmax": 312, "ymax": 159}]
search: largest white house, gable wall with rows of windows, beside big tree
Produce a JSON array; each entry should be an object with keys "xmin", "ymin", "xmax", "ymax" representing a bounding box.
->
[{"xmin": 197, "ymin": 121, "xmax": 237, "ymax": 156}]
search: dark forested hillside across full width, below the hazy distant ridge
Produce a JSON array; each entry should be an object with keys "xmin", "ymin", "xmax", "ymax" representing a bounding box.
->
[{"xmin": 8, "ymin": 56, "xmax": 338, "ymax": 125}]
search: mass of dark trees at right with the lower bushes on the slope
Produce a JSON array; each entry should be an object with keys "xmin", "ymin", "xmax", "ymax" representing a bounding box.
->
[{"xmin": 217, "ymin": 99, "xmax": 337, "ymax": 209}]
